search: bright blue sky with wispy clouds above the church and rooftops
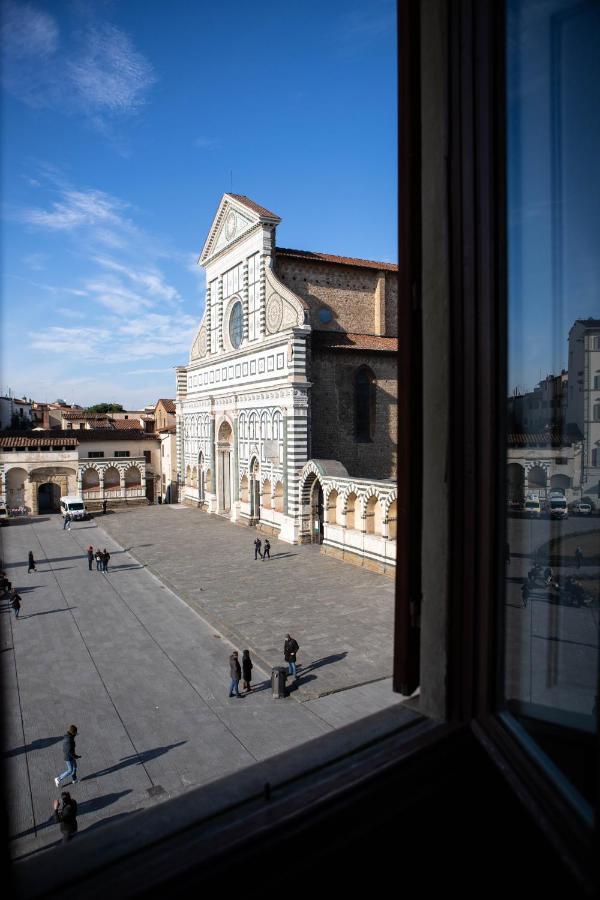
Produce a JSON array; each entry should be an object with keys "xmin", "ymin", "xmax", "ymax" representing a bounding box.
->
[{"xmin": 0, "ymin": 0, "xmax": 397, "ymax": 408}]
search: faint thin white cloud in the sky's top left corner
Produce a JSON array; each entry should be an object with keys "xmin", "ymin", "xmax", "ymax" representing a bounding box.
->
[{"xmin": 2, "ymin": 0, "xmax": 156, "ymax": 131}]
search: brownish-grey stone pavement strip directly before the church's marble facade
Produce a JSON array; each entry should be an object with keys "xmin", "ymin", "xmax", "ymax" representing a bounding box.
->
[{"xmin": 97, "ymin": 505, "xmax": 394, "ymax": 700}]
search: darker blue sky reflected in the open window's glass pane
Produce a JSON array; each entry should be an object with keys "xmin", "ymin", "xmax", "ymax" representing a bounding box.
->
[{"xmin": 508, "ymin": 0, "xmax": 600, "ymax": 391}]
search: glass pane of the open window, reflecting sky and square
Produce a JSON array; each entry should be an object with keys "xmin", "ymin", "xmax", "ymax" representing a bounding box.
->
[{"xmin": 502, "ymin": 0, "xmax": 600, "ymax": 815}]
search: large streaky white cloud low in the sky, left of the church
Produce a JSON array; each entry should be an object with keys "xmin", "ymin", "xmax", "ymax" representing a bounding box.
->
[{"xmin": 12, "ymin": 172, "xmax": 203, "ymax": 378}]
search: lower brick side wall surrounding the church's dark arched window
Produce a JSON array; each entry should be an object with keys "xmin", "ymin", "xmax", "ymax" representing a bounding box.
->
[{"xmin": 308, "ymin": 348, "xmax": 398, "ymax": 479}]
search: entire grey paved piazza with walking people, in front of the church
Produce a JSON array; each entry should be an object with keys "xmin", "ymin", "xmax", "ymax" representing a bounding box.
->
[{"xmin": 0, "ymin": 506, "xmax": 414, "ymax": 858}]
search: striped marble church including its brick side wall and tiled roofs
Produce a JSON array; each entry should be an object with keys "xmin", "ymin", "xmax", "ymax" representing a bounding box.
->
[{"xmin": 176, "ymin": 194, "xmax": 398, "ymax": 571}]
